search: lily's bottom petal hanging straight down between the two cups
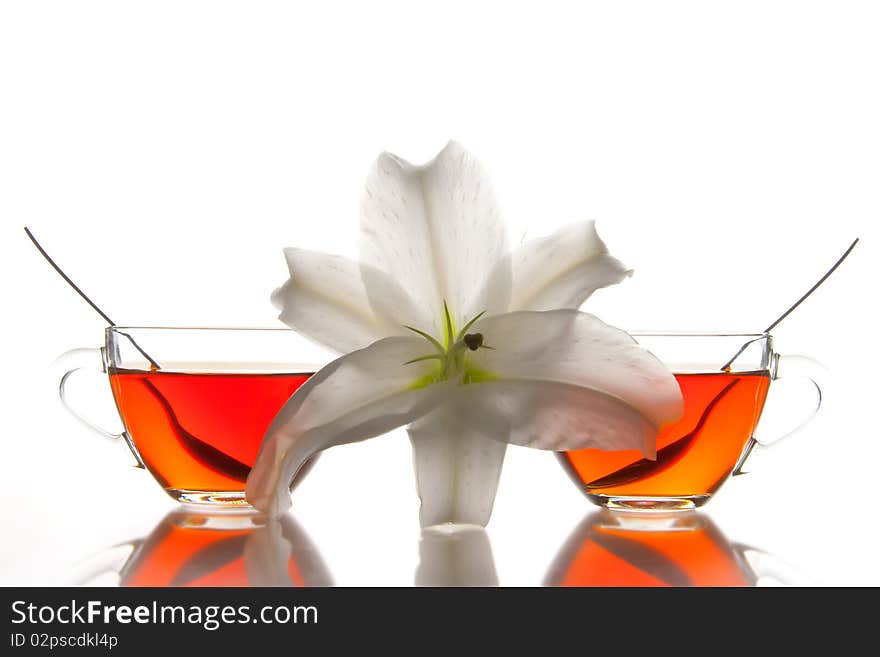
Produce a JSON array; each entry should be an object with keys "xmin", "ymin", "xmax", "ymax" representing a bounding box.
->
[{"xmin": 409, "ymin": 404, "xmax": 507, "ymax": 527}]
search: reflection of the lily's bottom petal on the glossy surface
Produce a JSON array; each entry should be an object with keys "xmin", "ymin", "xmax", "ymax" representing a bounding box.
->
[{"xmin": 415, "ymin": 527, "xmax": 498, "ymax": 586}]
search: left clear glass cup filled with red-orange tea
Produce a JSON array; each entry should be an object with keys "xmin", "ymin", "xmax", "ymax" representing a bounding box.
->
[{"xmin": 60, "ymin": 327, "xmax": 329, "ymax": 506}]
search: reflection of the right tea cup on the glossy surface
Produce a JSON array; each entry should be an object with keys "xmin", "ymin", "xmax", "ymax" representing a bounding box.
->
[{"xmin": 544, "ymin": 509, "xmax": 803, "ymax": 586}]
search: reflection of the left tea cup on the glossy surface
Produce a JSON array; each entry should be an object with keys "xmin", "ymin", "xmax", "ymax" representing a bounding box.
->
[{"xmin": 74, "ymin": 509, "xmax": 333, "ymax": 586}]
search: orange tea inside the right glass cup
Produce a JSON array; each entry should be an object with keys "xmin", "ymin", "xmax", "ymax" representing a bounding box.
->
[{"xmin": 559, "ymin": 371, "xmax": 770, "ymax": 499}]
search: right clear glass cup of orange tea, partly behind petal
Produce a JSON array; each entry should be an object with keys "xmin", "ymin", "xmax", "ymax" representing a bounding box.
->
[{"xmin": 558, "ymin": 333, "xmax": 821, "ymax": 510}]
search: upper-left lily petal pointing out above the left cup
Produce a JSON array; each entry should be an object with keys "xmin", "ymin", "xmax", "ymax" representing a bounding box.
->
[{"xmin": 272, "ymin": 248, "xmax": 426, "ymax": 353}]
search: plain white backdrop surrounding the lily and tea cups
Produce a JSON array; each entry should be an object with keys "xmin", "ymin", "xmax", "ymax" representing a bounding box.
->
[{"xmin": 0, "ymin": 0, "xmax": 880, "ymax": 585}]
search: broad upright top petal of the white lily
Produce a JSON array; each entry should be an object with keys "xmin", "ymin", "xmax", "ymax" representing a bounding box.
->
[{"xmin": 361, "ymin": 142, "xmax": 510, "ymax": 335}]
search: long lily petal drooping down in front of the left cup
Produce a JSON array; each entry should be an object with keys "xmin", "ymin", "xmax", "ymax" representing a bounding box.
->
[{"xmin": 247, "ymin": 337, "xmax": 450, "ymax": 516}]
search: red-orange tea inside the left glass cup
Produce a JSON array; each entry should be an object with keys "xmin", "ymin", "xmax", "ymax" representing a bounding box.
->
[{"xmin": 110, "ymin": 370, "xmax": 310, "ymax": 492}]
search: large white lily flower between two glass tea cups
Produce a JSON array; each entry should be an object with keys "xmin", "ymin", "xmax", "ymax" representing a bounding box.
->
[{"xmin": 247, "ymin": 143, "xmax": 682, "ymax": 527}]
